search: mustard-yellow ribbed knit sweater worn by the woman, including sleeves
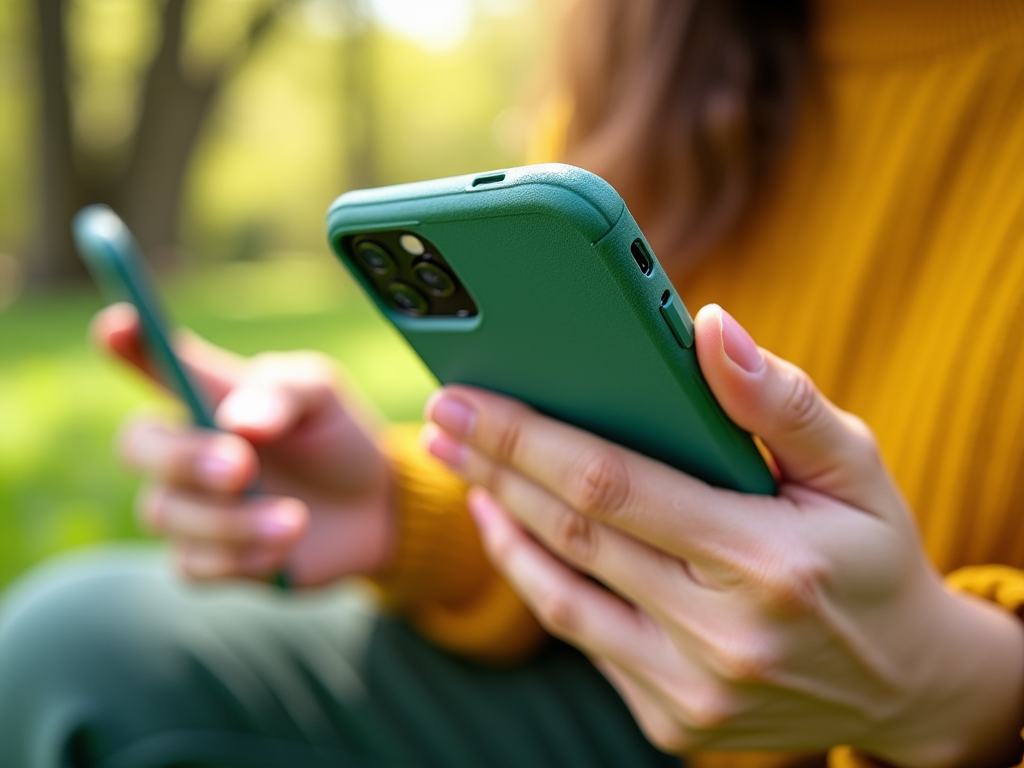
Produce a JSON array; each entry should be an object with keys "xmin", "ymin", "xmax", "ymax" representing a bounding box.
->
[{"xmin": 372, "ymin": 0, "xmax": 1024, "ymax": 768}]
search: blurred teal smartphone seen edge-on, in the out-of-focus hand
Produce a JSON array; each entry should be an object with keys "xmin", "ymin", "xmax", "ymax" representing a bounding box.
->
[{"xmin": 72, "ymin": 205, "xmax": 290, "ymax": 590}]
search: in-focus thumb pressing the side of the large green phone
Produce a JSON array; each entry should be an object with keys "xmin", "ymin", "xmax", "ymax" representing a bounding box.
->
[{"xmin": 694, "ymin": 304, "xmax": 892, "ymax": 512}]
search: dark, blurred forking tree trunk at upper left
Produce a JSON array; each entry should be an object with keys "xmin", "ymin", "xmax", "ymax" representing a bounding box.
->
[{"xmin": 30, "ymin": 0, "xmax": 276, "ymax": 284}]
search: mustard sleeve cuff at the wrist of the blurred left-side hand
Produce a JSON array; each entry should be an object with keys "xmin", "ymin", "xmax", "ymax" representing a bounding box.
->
[{"xmin": 371, "ymin": 425, "xmax": 545, "ymax": 662}]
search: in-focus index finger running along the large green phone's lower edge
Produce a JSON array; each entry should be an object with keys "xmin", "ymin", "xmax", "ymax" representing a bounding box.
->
[{"xmin": 426, "ymin": 386, "xmax": 775, "ymax": 563}]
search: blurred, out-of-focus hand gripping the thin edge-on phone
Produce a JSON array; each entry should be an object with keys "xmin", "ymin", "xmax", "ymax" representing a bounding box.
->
[{"xmin": 92, "ymin": 304, "xmax": 394, "ymax": 586}]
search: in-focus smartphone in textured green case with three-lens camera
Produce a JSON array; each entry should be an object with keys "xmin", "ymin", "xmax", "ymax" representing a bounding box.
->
[{"xmin": 327, "ymin": 164, "xmax": 775, "ymax": 494}]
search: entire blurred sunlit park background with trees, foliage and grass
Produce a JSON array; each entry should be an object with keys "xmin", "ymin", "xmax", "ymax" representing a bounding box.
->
[{"xmin": 0, "ymin": 0, "xmax": 557, "ymax": 586}]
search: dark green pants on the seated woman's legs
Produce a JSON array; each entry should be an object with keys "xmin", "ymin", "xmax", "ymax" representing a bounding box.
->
[{"xmin": 0, "ymin": 548, "xmax": 679, "ymax": 768}]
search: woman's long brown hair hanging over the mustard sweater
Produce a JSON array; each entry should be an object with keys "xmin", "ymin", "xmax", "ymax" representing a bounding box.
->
[{"xmin": 563, "ymin": 0, "xmax": 810, "ymax": 264}]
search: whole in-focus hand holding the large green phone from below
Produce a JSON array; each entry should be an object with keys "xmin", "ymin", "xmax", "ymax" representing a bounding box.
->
[{"xmin": 425, "ymin": 305, "xmax": 1024, "ymax": 768}]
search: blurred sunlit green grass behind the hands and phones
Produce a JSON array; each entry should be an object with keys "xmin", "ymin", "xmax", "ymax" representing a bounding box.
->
[{"xmin": 0, "ymin": 255, "xmax": 433, "ymax": 588}]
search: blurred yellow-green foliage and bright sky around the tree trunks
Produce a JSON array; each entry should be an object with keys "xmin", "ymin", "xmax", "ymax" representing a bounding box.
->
[{"xmin": 0, "ymin": 0, "xmax": 554, "ymax": 268}]
